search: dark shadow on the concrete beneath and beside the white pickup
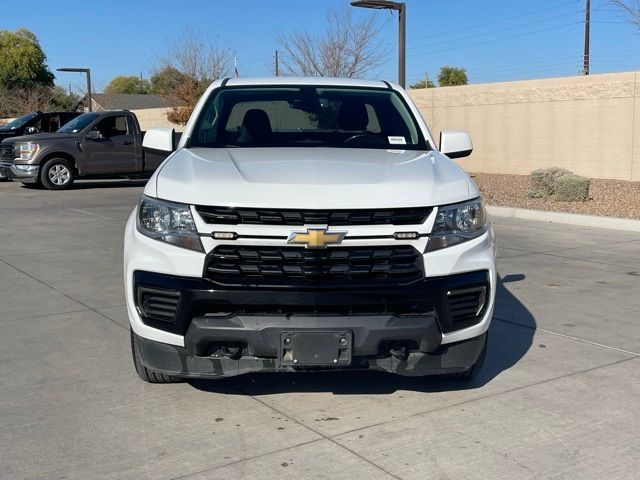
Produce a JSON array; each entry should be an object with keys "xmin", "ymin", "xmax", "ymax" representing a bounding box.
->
[{"xmin": 189, "ymin": 274, "xmax": 536, "ymax": 396}]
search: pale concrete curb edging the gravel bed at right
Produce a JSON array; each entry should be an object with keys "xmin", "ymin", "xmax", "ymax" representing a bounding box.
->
[{"xmin": 487, "ymin": 205, "xmax": 640, "ymax": 232}]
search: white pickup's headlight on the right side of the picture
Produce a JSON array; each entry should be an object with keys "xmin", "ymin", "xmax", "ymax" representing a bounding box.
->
[{"xmin": 427, "ymin": 198, "xmax": 487, "ymax": 251}]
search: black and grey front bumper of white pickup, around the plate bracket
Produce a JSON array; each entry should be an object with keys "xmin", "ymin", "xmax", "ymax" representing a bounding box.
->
[{"xmin": 134, "ymin": 271, "xmax": 491, "ymax": 377}]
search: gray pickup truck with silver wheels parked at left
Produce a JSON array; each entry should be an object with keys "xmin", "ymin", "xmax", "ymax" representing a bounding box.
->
[{"xmin": 0, "ymin": 110, "xmax": 171, "ymax": 190}]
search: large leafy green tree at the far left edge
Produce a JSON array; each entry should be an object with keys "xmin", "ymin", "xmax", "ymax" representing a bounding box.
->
[{"xmin": 0, "ymin": 28, "xmax": 54, "ymax": 88}]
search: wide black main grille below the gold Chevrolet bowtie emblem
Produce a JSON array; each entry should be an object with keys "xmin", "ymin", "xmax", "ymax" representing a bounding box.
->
[{"xmin": 204, "ymin": 245, "xmax": 424, "ymax": 288}]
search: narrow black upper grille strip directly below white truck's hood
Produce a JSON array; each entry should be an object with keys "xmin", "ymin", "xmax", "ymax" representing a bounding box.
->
[{"xmin": 196, "ymin": 206, "xmax": 432, "ymax": 225}]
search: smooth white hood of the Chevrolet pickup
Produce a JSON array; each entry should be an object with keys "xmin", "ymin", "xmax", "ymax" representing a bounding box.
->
[{"xmin": 152, "ymin": 147, "xmax": 477, "ymax": 209}]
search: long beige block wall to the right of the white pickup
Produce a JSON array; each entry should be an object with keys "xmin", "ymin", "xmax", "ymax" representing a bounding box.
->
[{"xmin": 410, "ymin": 72, "xmax": 640, "ymax": 182}]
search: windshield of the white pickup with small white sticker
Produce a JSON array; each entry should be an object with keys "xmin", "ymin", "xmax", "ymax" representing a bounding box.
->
[{"xmin": 189, "ymin": 86, "xmax": 429, "ymax": 150}]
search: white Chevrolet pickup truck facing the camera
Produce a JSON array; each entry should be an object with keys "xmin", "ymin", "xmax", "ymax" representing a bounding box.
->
[{"xmin": 124, "ymin": 78, "xmax": 496, "ymax": 383}]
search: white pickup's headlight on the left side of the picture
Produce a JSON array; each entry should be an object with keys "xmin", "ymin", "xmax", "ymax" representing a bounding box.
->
[{"xmin": 136, "ymin": 195, "xmax": 204, "ymax": 252}]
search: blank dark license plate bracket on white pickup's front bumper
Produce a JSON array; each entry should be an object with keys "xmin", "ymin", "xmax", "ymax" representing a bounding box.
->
[{"xmin": 278, "ymin": 330, "xmax": 353, "ymax": 366}]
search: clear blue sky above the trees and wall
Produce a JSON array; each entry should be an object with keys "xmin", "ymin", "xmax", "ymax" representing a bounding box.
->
[{"xmin": 0, "ymin": 0, "xmax": 640, "ymax": 91}]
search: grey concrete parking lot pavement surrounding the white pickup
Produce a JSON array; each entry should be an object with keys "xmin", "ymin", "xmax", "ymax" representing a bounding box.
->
[{"xmin": 0, "ymin": 181, "xmax": 640, "ymax": 480}]
